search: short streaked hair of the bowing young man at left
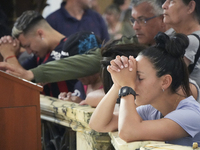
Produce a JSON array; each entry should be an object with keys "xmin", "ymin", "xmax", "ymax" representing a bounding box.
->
[{"xmin": 12, "ymin": 10, "xmax": 44, "ymax": 38}]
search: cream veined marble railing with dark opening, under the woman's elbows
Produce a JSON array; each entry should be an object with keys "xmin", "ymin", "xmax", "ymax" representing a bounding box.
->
[{"xmin": 40, "ymin": 95, "xmax": 200, "ymax": 150}]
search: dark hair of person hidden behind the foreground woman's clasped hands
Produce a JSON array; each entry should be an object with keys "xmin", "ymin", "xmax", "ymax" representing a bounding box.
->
[{"xmin": 101, "ymin": 40, "xmax": 146, "ymax": 93}]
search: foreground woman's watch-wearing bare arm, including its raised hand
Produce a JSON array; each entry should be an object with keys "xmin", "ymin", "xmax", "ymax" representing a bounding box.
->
[{"xmin": 108, "ymin": 57, "xmax": 188, "ymax": 142}]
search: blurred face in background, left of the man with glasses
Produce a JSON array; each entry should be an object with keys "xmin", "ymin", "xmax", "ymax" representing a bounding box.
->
[{"xmin": 105, "ymin": 4, "xmax": 120, "ymax": 25}]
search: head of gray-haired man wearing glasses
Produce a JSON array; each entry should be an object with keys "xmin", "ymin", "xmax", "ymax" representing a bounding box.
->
[{"xmin": 130, "ymin": 0, "xmax": 166, "ymax": 45}]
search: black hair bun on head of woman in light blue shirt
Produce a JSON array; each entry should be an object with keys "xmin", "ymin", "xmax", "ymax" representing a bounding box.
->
[{"xmin": 155, "ymin": 32, "xmax": 189, "ymax": 58}]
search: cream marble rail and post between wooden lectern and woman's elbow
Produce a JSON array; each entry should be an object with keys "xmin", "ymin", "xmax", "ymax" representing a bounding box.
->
[{"xmin": 40, "ymin": 95, "xmax": 113, "ymax": 150}]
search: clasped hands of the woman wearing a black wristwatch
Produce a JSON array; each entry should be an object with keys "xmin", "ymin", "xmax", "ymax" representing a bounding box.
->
[{"xmin": 107, "ymin": 56, "xmax": 137, "ymax": 88}]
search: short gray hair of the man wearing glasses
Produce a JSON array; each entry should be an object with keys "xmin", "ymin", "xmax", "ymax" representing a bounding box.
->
[{"xmin": 131, "ymin": 0, "xmax": 165, "ymax": 15}]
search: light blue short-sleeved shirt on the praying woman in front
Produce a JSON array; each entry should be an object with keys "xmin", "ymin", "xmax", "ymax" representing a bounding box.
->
[{"xmin": 137, "ymin": 96, "xmax": 200, "ymax": 146}]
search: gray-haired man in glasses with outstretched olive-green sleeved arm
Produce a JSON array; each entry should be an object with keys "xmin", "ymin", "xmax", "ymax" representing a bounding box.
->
[{"xmin": 0, "ymin": 0, "xmax": 169, "ymax": 83}]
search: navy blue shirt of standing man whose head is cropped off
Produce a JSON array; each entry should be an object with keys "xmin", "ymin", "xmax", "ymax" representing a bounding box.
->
[{"xmin": 46, "ymin": 2, "xmax": 109, "ymax": 41}]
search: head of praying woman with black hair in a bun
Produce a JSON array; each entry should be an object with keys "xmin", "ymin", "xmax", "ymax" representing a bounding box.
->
[{"xmin": 135, "ymin": 32, "xmax": 190, "ymax": 105}]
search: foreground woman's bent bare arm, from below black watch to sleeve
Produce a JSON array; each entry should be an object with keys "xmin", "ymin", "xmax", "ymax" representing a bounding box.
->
[{"xmin": 118, "ymin": 95, "xmax": 188, "ymax": 142}]
